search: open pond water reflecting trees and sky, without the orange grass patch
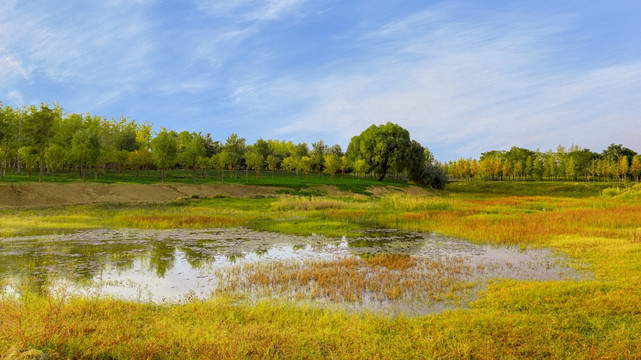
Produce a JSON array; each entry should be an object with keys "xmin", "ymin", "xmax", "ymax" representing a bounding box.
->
[{"xmin": 0, "ymin": 228, "xmax": 579, "ymax": 312}]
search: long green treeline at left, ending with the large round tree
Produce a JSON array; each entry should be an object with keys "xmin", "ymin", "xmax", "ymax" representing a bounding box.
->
[{"xmin": 0, "ymin": 103, "xmax": 447, "ymax": 188}]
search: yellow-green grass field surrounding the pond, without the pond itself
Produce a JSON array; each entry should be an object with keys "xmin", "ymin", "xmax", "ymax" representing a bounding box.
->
[{"xmin": 0, "ymin": 181, "xmax": 641, "ymax": 359}]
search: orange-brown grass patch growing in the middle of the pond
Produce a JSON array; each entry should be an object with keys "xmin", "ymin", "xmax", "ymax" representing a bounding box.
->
[{"xmin": 218, "ymin": 254, "xmax": 473, "ymax": 303}]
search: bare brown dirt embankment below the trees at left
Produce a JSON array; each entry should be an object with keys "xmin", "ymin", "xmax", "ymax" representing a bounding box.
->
[{"xmin": 0, "ymin": 183, "xmax": 278, "ymax": 207}]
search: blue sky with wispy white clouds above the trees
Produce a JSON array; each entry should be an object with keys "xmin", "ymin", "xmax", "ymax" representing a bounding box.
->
[{"xmin": 0, "ymin": 0, "xmax": 641, "ymax": 161}]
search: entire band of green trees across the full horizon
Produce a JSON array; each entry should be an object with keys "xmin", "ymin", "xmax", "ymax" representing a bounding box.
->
[{"xmin": 0, "ymin": 104, "xmax": 641, "ymax": 192}]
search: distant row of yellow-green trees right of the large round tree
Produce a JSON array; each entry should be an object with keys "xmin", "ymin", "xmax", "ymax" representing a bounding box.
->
[{"xmin": 444, "ymin": 144, "xmax": 641, "ymax": 182}]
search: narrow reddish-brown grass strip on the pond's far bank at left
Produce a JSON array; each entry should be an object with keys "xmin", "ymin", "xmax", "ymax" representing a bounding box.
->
[{"xmin": 116, "ymin": 214, "xmax": 247, "ymax": 229}]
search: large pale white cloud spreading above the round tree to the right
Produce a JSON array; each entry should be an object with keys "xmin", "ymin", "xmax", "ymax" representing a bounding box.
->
[{"xmin": 226, "ymin": 5, "xmax": 641, "ymax": 158}]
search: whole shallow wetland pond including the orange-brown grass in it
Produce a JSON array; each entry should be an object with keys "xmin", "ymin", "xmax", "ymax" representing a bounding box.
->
[{"xmin": 0, "ymin": 228, "xmax": 586, "ymax": 315}]
